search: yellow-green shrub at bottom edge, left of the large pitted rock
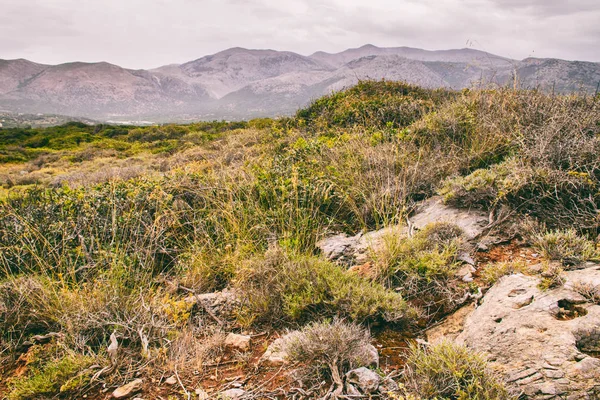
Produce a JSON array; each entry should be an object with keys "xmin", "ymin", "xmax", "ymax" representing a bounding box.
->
[{"xmin": 405, "ymin": 341, "xmax": 513, "ymax": 400}]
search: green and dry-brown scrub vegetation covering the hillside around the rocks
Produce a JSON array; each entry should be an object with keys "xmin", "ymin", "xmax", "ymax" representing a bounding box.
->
[{"xmin": 0, "ymin": 82, "xmax": 600, "ymax": 398}]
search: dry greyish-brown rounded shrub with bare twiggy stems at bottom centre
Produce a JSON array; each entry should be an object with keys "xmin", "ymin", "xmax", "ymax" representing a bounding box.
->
[{"xmin": 282, "ymin": 319, "xmax": 372, "ymax": 384}]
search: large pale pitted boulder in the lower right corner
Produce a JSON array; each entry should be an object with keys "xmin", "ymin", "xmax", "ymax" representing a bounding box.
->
[{"xmin": 454, "ymin": 265, "xmax": 600, "ymax": 399}]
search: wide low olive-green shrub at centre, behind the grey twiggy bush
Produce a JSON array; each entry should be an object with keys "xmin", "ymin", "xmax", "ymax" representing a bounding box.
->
[{"xmin": 235, "ymin": 248, "xmax": 411, "ymax": 324}]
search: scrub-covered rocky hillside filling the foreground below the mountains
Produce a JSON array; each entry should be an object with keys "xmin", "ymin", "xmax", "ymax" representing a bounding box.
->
[{"xmin": 0, "ymin": 82, "xmax": 600, "ymax": 400}]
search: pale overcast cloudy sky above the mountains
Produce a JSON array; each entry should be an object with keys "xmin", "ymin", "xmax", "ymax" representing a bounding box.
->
[{"xmin": 0, "ymin": 0, "xmax": 600, "ymax": 68}]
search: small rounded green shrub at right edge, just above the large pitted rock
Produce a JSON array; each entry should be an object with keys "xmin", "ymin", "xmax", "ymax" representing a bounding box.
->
[{"xmin": 530, "ymin": 229, "xmax": 599, "ymax": 266}]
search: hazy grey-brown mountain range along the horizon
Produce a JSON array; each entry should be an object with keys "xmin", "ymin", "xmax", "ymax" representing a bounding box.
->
[{"xmin": 0, "ymin": 45, "xmax": 600, "ymax": 122}]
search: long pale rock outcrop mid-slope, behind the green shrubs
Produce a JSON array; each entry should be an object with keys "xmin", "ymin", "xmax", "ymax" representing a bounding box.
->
[{"xmin": 317, "ymin": 196, "xmax": 497, "ymax": 266}]
